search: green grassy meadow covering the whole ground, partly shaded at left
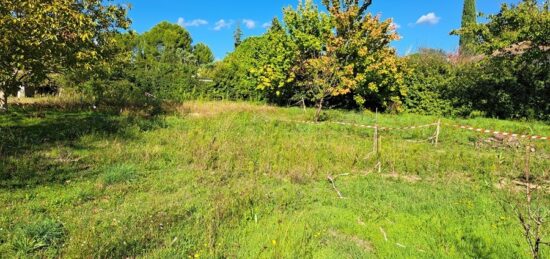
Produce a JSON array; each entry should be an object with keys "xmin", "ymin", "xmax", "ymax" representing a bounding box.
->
[{"xmin": 0, "ymin": 102, "xmax": 550, "ymax": 258}]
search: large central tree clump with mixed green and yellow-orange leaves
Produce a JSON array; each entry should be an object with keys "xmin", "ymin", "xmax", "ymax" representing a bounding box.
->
[{"xmin": 240, "ymin": 0, "xmax": 407, "ymax": 116}]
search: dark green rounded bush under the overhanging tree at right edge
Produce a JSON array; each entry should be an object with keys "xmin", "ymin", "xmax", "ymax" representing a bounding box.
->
[{"xmin": 450, "ymin": 56, "xmax": 550, "ymax": 121}]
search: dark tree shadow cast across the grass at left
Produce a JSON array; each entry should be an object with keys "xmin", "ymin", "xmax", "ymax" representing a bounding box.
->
[{"xmin": 0, "ymin": 106, "xmax": 164, "ymax": 188}]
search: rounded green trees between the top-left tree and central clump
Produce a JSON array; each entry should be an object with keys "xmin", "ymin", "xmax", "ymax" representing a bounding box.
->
[{"xmin": 64, "ymin": 22, "xmax": 214, "ymax": 106}]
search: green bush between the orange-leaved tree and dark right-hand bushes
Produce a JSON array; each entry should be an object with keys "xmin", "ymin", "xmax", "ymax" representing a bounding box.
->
[{"xmin": 404, "ymin": 49, "xmax": 455, "ymax": 116}]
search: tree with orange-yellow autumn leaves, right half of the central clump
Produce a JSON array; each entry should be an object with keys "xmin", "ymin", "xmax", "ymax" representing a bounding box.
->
[{"xmin": 323, "ymin": 0, "xmax": 408, "ymax": 112}]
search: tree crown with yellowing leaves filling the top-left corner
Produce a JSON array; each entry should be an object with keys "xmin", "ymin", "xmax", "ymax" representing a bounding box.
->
[{"xmin": 0, "ymin": 0, "xmax": 130, "ymax": 109}]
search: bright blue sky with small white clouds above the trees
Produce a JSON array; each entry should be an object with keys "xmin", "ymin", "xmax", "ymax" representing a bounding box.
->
[{"xmin": 124, "ymin": 0, "xmax": 519, "ymax": 59}]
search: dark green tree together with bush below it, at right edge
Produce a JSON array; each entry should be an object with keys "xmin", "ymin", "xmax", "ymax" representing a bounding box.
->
[{"xmin": 453, "ymin": 1, "xmax": 550, "ymax": 120}]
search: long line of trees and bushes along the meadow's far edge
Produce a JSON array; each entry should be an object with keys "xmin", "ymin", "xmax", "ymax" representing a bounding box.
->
[{"xmin": 0, "ymin": 0, "xmax": 550, "ymax": 120}]
